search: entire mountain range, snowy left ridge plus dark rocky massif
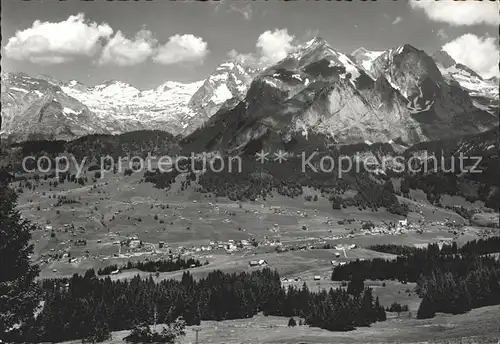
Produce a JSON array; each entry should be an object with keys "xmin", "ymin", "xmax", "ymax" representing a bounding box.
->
[{"xmin": 1, "ymin": 38, "xmax": 499, "ymax": 150}]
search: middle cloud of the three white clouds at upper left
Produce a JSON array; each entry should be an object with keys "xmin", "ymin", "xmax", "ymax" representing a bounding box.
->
[{"xmin": 99, "ymin": 30, "xmax": 157, "ymax": 66}]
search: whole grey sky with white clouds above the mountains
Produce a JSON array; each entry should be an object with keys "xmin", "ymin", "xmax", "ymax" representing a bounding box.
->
[{"xmin": 1, "ymin": 0, "xmax": 500, "ymax": 89}]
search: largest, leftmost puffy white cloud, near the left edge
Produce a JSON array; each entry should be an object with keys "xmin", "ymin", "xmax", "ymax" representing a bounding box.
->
[{"xmin": 4, "ymin": 13, "xmax": 113, "ymax": 64}]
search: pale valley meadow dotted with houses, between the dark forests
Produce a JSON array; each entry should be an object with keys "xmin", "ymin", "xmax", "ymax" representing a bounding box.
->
[{"xmin": 20, "ymin": 167, "xmax": 485, "ymax": 281}]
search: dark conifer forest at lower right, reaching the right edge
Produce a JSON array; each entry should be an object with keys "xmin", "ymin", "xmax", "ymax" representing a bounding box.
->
[{"xmin": 332, "ymin": 242, "xmax": 500, "ymax": 319}]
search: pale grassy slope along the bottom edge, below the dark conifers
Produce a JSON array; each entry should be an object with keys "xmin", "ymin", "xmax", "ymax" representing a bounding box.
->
[{"xmin": 59, "ymin": 306, "xmax": 499, "ymax": 344}]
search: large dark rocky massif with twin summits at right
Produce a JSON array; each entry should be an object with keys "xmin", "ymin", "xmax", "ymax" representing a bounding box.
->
[{"xmin": 184, "ymin": 38, "xmax": 498, "ymax": 151}]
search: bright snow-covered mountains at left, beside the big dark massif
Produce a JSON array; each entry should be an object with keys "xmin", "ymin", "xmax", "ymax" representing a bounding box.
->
[{"xmin": 1, "ymin": 61, "xmax": 257, "ymax": 141}]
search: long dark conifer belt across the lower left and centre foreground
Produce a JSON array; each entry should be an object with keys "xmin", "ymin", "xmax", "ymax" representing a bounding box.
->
[{"xmin": 16, "ymin": 268, "xmax": 385, "ymax": 342}]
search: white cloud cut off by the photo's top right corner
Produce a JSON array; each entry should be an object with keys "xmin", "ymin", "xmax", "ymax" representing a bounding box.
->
[{"xmin": 410, "ymin": 0, "xmax": 500, "ymax": 26}]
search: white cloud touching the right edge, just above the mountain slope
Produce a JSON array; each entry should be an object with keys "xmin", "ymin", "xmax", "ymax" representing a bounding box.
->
[{"xmin": 443, "ymin": 33, "xmax": 500, "ymax": 78}]
